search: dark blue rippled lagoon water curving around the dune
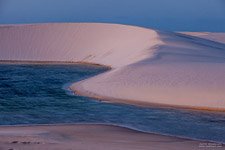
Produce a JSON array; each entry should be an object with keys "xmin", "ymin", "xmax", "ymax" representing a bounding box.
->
[{"xmin": 0, "ymin": 64, "xmax": 225, "ymax": 142}]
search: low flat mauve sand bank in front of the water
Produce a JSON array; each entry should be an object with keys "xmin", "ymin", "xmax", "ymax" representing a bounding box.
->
[{"xmin": 0, "ymin": 125, "xmax": 224, "ymax": 150}]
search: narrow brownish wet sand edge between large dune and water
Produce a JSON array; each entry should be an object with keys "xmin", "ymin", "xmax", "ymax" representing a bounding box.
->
[{"xmin": 0, "ymin": 60, "xmax": 225, "ymax": 113}]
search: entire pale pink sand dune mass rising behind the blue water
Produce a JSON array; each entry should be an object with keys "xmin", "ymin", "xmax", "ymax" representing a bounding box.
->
[{"xmin": 0, "ymin": 23, "xmax": 225, "ymax": 110}]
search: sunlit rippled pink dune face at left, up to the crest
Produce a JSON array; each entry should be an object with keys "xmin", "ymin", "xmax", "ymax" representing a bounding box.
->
[{"xmin": 0, "ymin": 23, "xmax": 159, "ymax": 67}]
